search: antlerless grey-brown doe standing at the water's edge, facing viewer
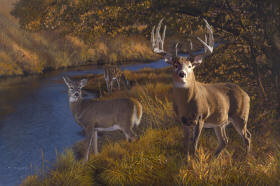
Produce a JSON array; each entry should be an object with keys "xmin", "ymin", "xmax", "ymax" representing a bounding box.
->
[{"xmin": 63, "ymin": 77, "xmax": 142, "ymax": 160}]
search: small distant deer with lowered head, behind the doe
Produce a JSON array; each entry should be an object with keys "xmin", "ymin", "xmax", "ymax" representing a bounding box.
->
[{"xmin": 104, "ymin": 66, "xmax": 129, "ymax": 93}]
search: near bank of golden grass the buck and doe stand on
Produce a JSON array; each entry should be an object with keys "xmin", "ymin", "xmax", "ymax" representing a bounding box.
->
[{"xmin": 22, "ymin": 56, "xmax": 280, "ymax": 185}]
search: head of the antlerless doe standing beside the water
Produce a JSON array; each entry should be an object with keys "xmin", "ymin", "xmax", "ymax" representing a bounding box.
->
[{"xmin": 63, "ymin": 76, "xmax": 87, "ymax": 102}]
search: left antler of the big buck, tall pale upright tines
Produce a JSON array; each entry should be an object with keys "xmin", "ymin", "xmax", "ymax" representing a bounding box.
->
[{"xmin": 151, "ymin": 18, "xmax": 166, "ymax": 55}]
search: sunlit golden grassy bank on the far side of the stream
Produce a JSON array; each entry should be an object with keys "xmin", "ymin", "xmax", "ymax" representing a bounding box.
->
[{"xmin": 0, "ymin": 0, "xmax": 158, "ymax": 77}]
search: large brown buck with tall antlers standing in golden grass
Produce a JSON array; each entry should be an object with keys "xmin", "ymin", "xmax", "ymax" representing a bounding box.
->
[{"xmin": 151, "ymin": 19, "xmax": 251, "ymax": 156}]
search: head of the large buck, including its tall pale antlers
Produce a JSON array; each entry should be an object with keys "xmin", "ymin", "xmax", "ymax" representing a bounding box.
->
[{"xmin": 151, "ymin": 19, "xmax": 214, "ymax": 88}]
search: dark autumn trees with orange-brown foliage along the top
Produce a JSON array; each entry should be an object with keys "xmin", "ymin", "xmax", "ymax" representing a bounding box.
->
[{"xmin": 12, "ymin": 0, "xmax": 280, "ymax": 110}]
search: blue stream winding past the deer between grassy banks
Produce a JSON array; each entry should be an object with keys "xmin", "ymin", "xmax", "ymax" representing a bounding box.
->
[{"xmin": 0, "ymin": 60, "xmax": 167, "ymax": 186}]
